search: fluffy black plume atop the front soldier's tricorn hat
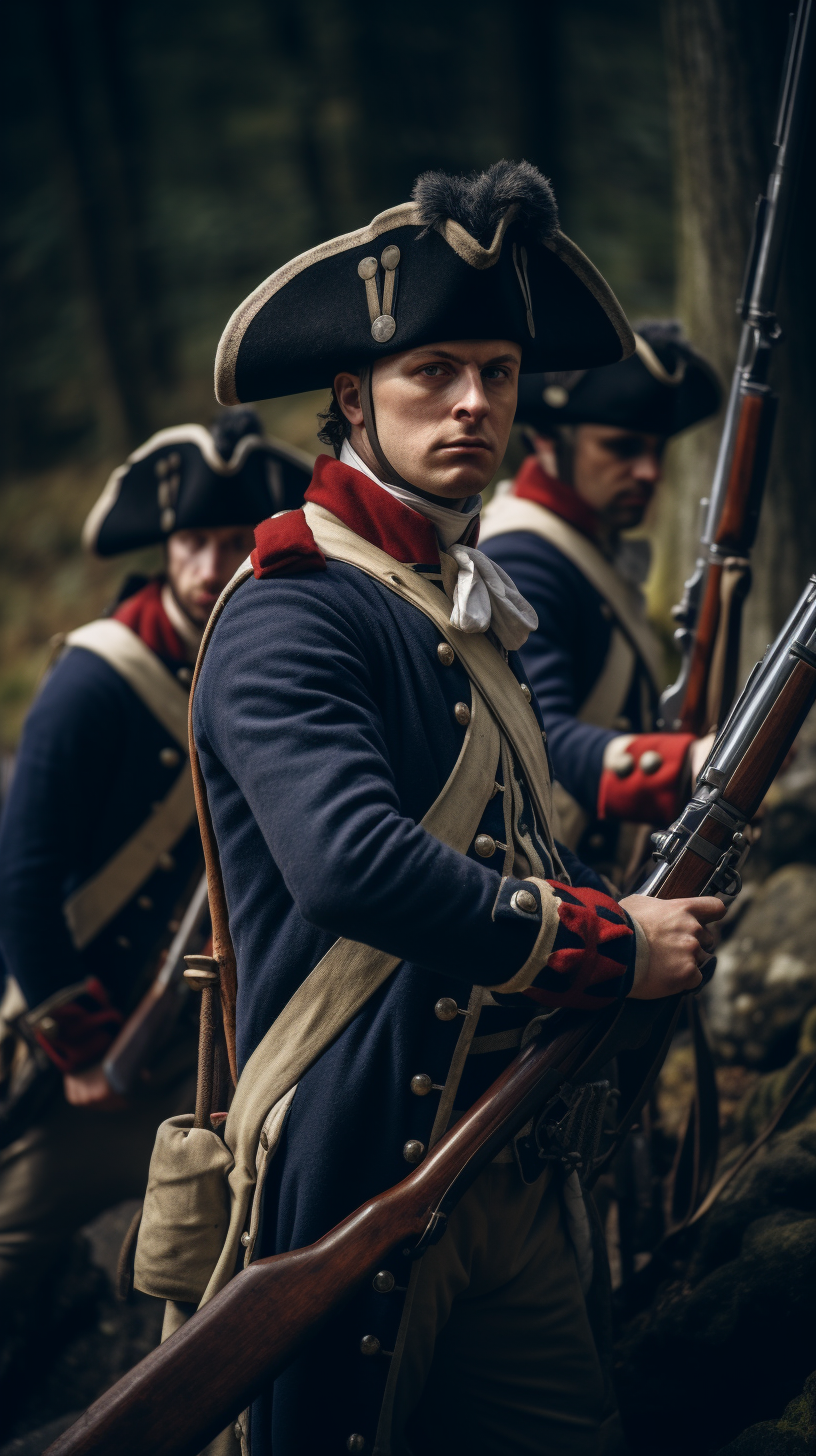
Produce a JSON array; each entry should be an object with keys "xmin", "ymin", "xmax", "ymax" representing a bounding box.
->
[{"xmin": 411, "ymin": 162, "xmax": 558, "ymax": 246}]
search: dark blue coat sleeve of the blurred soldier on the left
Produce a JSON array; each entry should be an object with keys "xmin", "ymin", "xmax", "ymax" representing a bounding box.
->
[{"xmin": 0, "ymin": 649, "xmax": 124, "ymax": 1006}]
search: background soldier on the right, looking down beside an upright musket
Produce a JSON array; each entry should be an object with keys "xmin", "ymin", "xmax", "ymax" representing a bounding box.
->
[{"xmin": 482, "ymin": 320, "xmax": 721, "ymax": 884}]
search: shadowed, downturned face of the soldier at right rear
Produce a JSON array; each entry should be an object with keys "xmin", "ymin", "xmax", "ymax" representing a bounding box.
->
[{"xmin": 573, "ymin": 425, "xmax": 666, "ymax": 531}]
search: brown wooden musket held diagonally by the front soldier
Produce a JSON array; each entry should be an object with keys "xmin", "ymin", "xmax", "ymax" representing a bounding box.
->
[{"xmin": 47, "ymin": 564, "xmax": 816, "ymax": 1456}]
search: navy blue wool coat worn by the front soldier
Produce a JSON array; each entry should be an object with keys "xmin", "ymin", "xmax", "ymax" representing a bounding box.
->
[{"xmin": 194, "ymin": 562, "xmax": 617, "ymax": 1456}]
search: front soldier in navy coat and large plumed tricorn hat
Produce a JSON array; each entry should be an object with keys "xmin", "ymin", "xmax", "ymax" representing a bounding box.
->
[{"xmin": 159, "ymin": 162, "xmax": 721, "ymax": 1456}]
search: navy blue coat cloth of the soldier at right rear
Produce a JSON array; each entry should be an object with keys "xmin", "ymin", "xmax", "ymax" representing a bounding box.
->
[{"xmin": 479, "ymin": 531, "xmax": 653, "ymax": 814}]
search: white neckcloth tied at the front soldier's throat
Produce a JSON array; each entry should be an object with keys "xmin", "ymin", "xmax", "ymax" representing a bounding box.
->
[{"xmin": 340, "ymin": 440, "xmax": 538, "ymax": 652}]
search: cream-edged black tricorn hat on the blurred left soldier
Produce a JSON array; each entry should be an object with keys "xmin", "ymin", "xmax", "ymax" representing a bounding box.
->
[{"xmin": 82, "ymin": 408, "xmax": 313, "ymax": 556}]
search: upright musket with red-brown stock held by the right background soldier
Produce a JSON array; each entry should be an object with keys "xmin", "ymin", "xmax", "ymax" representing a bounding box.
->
[{"xmin": 659, "ymin": 0, "xmax": 813, "ymax": 734}]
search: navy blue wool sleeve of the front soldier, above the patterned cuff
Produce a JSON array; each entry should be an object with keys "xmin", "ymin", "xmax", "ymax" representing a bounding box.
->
[{"xmin": 194, "ymin": 568, "xmax": 538, "ymax": 986}]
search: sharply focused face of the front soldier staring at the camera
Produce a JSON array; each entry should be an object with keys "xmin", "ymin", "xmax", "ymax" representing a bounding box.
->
[{"xmin": 335, "ymin": 339, "xmax": 522, "ymax": 499}]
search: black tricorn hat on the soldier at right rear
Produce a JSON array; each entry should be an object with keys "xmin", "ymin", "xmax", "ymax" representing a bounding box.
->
[{"xmin": 516, "ymin": 320, "xmax": 723, "ymax": 437}]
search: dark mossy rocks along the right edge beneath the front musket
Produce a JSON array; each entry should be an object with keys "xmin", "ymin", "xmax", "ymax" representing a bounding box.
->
[{"xmin": 616, "ymin": 710, "xmax": 816, "ymax": 1456}]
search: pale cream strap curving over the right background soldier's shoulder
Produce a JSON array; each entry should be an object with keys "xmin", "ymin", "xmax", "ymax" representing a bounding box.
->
[{"xmin": 479, "ymin": 494, "xmax": 663, "ymax": 689}]
